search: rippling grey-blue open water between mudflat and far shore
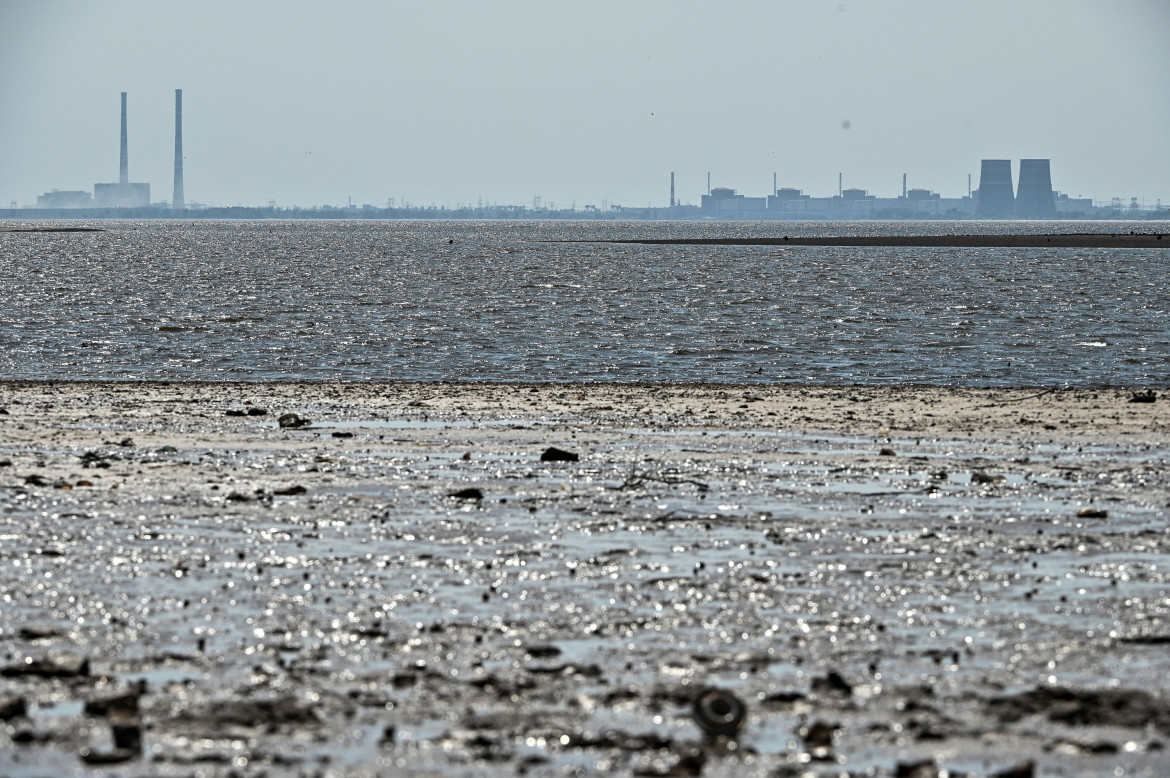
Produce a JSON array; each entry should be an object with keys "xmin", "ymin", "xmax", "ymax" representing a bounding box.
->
[{"xmin": 0, "ymin": 221, "xmax": 1170, "ymax": 386}]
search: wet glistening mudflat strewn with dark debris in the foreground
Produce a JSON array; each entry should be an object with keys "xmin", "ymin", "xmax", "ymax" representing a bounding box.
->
[{"xmin": 0, "ymin": 383, "xmax": 1170, "ymax": 778}]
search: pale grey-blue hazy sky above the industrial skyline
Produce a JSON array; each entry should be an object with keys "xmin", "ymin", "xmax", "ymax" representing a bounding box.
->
[{"xmin": 0, "ymin": 0, "xmax": 1170, "ymax": 208}]
